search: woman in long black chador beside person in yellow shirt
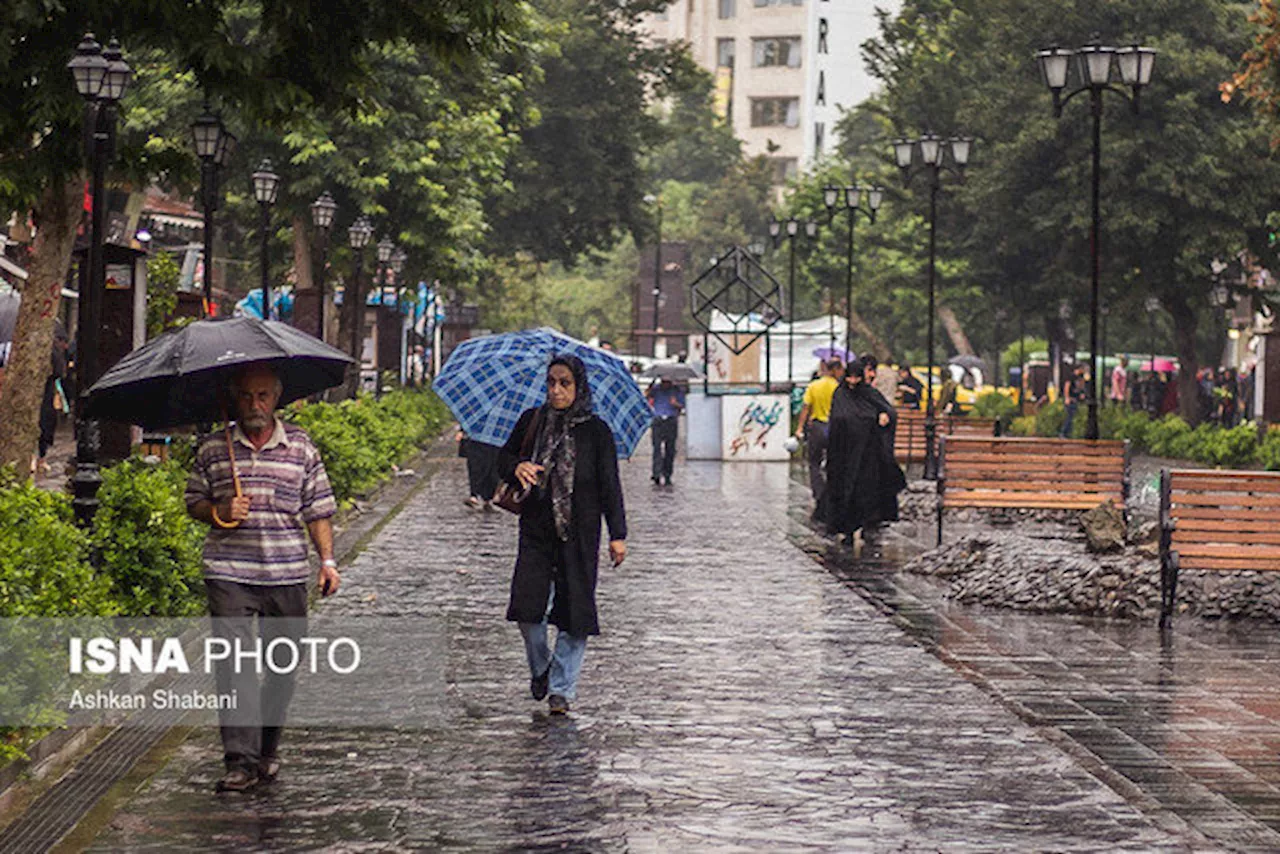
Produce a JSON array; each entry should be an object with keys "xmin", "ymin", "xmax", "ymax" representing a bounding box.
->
[{"xmin": 818, "ymin": 362, "xmax": 906, "ymax": 543}]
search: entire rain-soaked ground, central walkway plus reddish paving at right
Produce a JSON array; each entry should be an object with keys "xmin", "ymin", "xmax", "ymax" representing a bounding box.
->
[{"xmin": 80, "ymin": 450, "xmax": 1280, "ymax": 851}]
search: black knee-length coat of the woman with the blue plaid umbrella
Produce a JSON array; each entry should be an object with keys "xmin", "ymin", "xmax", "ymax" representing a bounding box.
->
[{"xmin": 498, "ymin": 408, "xmax": 627, "ymax": 636}]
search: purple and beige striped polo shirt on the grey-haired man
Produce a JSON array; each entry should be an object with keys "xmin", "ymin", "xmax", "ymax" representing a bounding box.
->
[{"xmin": 186, "ymin": 419, "xmax": 338, "ymax": 585}]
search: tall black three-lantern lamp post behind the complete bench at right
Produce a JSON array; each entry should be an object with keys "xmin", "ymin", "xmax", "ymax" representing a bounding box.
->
[{"xmin": 1036, "ymin": 40, "xmax": 1156, "ymax": 439}]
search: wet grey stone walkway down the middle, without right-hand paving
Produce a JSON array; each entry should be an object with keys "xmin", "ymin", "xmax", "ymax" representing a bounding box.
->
[{"xmin": 85, "ymin": 450, "xmax": 1215, "ymax": 851}]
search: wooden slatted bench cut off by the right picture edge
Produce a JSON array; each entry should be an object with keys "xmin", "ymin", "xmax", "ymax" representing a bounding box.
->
[{"xmin": 1160, "ymin": 469, "xmax": 1280, "ymax": 627}]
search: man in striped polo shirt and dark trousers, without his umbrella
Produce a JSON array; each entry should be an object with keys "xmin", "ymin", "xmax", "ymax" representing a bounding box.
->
[{"xmin": 186, "ymin": 362, "xmax": 339, "ymax": 791}]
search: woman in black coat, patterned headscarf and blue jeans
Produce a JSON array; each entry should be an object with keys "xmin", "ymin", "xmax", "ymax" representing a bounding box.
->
[{"xmin": 498, "ymin": 355, "xmax": 627, "ymax": 714}]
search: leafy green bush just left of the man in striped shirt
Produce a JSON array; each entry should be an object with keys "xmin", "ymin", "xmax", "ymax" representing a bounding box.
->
[{"xmin": 92, "ymin": 460, "xmax": 206, "ymax": 617}]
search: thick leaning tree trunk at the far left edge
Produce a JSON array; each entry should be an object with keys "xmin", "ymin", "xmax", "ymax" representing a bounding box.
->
[{"xmin": 0, "ymin": 179, "xmax": 84, "ymax": 476}]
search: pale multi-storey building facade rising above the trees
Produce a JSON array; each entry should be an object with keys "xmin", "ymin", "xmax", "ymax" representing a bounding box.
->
[{"xmin": 645, "ymin": 0, "xmax": 897, "ymax": 183}]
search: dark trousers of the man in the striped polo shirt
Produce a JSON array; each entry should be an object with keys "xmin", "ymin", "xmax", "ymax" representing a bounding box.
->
[{"xmin": 205, "ymin": 579, "xmax": 307, "ymax": 773}]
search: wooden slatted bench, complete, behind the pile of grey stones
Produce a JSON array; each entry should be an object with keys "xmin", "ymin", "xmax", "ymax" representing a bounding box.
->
[{"xmin": 937, "ymin": 435, "xmax": 1129, "ymax": 545}]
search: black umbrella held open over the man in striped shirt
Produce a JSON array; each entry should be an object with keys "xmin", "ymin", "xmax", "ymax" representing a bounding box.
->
[{"xmin": 86, "ymin": 318, "xmax": 353, "ymax": 430}]
